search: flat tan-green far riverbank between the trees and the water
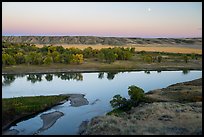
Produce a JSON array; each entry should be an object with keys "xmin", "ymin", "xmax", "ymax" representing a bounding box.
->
[{"xmin": 2, "ymin": 57, "xmax": 202, "ymax": 74}]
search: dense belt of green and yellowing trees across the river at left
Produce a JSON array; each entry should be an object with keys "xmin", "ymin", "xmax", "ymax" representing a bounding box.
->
[{"xmin": 2, "ymin": 42, "xmax": 135, "ymax": 66}]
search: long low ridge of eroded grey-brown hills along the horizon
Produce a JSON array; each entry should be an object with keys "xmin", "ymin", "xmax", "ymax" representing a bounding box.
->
[{"xmin": 2, "ymin": 36, "xmax": 202, "ymax": 45}]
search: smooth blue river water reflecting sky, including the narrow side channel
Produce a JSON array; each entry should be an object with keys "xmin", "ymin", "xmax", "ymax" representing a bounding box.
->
[{"xmin": 2, "ymin": 71, "xmax": 202, "ymax": 134}]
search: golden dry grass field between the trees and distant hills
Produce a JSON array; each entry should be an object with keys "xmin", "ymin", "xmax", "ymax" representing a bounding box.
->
[{"xmin": 36, "ymin": 44, "xmax": 202, "ymax": 54}]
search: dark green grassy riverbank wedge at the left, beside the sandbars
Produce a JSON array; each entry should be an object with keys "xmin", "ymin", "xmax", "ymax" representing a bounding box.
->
[{"xmin": 2, "ymin": 95, "xmax": 69, "ymax": 130}]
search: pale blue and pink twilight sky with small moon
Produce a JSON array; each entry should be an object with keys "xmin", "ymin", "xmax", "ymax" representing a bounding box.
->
[{"xmin": 2, "ymin": 2, "xmax": 202, "ymax": 38}]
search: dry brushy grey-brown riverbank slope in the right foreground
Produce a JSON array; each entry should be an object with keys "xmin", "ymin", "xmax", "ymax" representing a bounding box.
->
[{"xmin": 80, "ymin": 78, "xmax": 202, "ymax": 135}]
